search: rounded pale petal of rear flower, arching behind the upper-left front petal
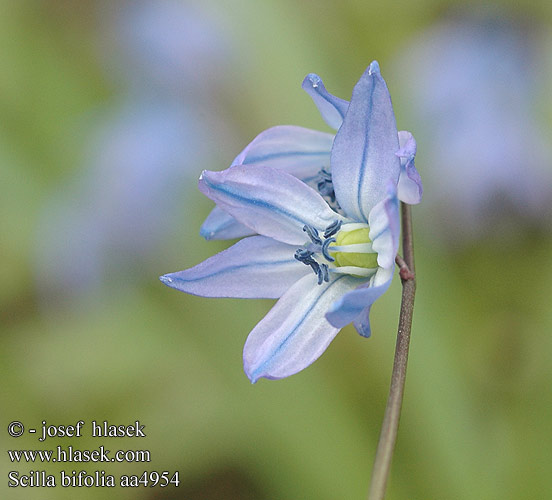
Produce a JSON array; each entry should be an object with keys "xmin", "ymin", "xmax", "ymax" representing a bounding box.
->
[{"xmin": 232, "ymin": 125, "xmax": 334, "ymax": 181}]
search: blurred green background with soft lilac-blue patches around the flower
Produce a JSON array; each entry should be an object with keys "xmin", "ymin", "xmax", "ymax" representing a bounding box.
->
[{"xmin": 0, "ymin": 0, "xmax": 552, "ymax": 500}]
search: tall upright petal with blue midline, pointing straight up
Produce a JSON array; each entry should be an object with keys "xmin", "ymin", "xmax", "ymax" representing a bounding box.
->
[{"xmin": 331, "ymin": 61, "xmax": 400, "ymax": 222}]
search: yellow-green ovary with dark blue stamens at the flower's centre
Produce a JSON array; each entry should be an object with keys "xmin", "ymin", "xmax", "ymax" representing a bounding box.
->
[{"xmin": 295, "ymin": 220, "xmax": 378, "ymax": 285}]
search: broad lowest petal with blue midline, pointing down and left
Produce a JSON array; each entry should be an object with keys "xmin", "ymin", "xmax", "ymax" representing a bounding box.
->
[{"xmin": 243, "ymin": 273, "xmax": 358, "ymax": 383}]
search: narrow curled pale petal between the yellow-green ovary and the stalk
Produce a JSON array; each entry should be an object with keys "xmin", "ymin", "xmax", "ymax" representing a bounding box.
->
[{"xmin": 368, "ymin": 182, "xmax": 400, "ymax": 269}]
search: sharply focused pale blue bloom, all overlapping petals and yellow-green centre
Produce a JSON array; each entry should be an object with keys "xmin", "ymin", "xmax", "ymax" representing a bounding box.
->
[{"xmin": 161, "ymin": 61, "xmax": 421, "ymax": 382}]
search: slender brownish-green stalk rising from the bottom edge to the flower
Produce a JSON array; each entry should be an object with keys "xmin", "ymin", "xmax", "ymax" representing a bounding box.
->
[{"xmin": 368, "ymin": 203, "xmax": 416, "ymax": 500}]
